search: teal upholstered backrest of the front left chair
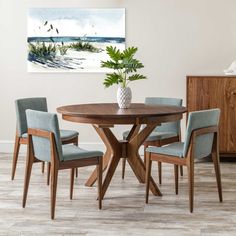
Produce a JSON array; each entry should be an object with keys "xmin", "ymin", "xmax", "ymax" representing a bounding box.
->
[{"xmin": 26, "ymin": 110, "xmax": 63, "ymax": 161}]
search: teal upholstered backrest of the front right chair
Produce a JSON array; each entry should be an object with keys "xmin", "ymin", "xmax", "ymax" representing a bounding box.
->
[{"xmin": 183, "ymin": 109, "xmax": 220, "ymax": 158}]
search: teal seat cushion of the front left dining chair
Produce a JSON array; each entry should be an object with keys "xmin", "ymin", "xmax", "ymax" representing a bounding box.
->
[{"xmin": 62, "ymin": 144, "xmax": 103, "ymax": 161}]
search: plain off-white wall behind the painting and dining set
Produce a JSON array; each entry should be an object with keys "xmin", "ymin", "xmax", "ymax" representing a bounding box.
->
[{"xmin": 0, "ymin": 0, "xmax": 236, "ymax": 152}]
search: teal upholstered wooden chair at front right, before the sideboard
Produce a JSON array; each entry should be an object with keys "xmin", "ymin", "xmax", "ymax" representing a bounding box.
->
[{"xmin": 146, "ymin": 109, "xmax": 222, "ymax": 212}]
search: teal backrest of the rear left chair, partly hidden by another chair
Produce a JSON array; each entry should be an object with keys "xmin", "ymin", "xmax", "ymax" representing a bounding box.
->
[{"xmin": 15, "ymin": 97, "xmax": 48, "ymax": 137}]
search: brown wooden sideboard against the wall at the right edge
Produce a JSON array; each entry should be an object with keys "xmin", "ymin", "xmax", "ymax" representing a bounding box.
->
[{"xmin": 187, "ymin": 75, "xmax": 236, "ymax": 157}]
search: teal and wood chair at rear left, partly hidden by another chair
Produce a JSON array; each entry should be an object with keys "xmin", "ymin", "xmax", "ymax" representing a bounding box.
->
[{"xmin": 11, "ymin": 97, "xmax": 79, "ymax": 184}]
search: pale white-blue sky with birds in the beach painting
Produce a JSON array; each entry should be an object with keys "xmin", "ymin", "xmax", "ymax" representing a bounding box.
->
[{"xmin": 28, "ymin": 8, "xmax": 125, "ymax": 38}]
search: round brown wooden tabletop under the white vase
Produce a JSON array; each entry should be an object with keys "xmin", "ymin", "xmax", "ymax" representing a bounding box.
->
[{"xmin": 57, "ymin": 103, "xmax": 187, "ymax": 124}]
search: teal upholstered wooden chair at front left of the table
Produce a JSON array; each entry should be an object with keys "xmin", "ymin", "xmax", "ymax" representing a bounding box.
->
[{"xmin": 23, "ymin": 110, "xmax": 103, "ymax": 219}]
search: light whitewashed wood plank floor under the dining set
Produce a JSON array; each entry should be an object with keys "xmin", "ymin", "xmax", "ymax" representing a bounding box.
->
[{"xmin": 0, "ymin": 154, "xmax": 236, "ymax": 236}]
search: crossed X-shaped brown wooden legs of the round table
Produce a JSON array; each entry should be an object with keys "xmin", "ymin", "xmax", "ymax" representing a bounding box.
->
[{"xmin": 85, "ymin": 124, "xmax": 162, "ymax": 197}]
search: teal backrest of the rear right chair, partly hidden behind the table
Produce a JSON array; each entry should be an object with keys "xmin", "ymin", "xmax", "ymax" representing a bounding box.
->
[{"xmin": 145, "ymin": 97, "xmax": 183, "ymax": 134}]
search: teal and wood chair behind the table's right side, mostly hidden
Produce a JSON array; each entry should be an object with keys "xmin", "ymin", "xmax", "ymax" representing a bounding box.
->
[{"xmin": 122, "ymin": 97, "xmax": 183, "ymax": 184}]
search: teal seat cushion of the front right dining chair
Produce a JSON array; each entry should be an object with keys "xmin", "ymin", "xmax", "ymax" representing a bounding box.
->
[{"xmin": 146, "ymin": 142, "xmax": 184, "ymax": 158}]
